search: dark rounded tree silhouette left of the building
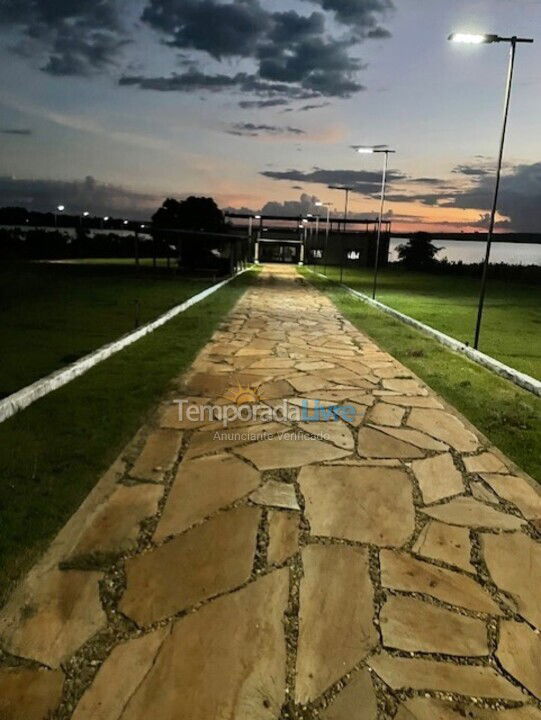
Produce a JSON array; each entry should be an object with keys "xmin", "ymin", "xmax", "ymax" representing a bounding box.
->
[{"xmin": 152, "ymin": 197, "xmax": 225, "ymax": 232}]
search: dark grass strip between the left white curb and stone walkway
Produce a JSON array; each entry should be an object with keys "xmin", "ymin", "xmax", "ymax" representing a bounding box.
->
[{"xmin": 0, "ymin": 273, "xmax": 255, "ymax": 605}]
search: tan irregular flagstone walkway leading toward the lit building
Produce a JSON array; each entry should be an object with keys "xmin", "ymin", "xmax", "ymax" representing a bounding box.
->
[{"xmin": 0, "ymin": 266, "xmax": 541, "ymax": 720}]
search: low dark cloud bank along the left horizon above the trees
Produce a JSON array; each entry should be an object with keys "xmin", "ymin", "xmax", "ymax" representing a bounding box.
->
[{"xmin": 0, "ymin": 177, "xmax": 163, "ymax": 219}]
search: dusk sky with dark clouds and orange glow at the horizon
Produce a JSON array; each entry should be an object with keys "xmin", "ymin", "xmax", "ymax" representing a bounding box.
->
[{"xmin": 0, "ymin": 0, "xmax": 541, "ymax": 232}]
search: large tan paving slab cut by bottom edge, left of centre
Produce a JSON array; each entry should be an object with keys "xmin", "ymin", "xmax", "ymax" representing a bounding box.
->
[{"xmin": 118, "ymin": 569, "xmax": 289, "ymax": 720}]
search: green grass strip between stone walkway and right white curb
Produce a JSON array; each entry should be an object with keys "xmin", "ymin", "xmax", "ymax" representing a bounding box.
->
[{"xmin": 302, "ymin": 270, "xmax": 541, "ymax": 482}]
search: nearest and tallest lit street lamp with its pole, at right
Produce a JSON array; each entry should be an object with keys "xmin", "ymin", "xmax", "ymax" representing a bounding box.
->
[{"xmin": 449, "ymin": 33, "xmax": 533, "ymax": 350}]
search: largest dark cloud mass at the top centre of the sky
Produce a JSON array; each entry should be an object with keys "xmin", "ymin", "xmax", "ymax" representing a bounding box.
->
[{"xmin": 135, "ymin": 0, "xmax": 390, "ymax": 102}]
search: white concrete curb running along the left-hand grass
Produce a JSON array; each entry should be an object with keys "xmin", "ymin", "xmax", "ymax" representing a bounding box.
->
[{"xmin": 0, "ymin": 268, "xmax": 250, "ymax": 423}]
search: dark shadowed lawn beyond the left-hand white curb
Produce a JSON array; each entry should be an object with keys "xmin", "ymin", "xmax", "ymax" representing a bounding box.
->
[{"xmin": 0, "ymin": 261, "xmax": 212, "ymax": 397}]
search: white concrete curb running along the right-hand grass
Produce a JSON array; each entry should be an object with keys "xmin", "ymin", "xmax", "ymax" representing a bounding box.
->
[{"xmin": 307, "ymin": 268, "xmax": 541, "ymax": 397}]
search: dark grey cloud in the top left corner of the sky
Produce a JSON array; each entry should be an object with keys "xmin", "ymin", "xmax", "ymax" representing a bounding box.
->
[{"xmin": 0, "ymin": 0, "xmax": 128, "ymax": 75}]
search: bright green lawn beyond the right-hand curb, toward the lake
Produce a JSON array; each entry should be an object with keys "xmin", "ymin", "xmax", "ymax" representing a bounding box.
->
[{"xmin": 308, "ymin": 267, "xmax": 541, "ymax": 379}]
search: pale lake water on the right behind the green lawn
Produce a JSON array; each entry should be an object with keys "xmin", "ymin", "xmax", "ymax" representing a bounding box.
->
[{"xmin": 389, "ymin": 238, "xmax": 541, "ymax": 265}]
